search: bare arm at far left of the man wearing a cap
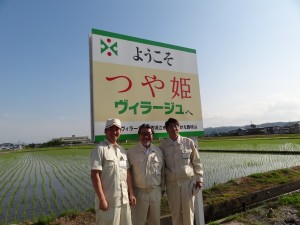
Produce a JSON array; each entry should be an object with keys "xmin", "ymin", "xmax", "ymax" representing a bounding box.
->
[{"xmin": 91, "ymin": 170, "xmax": 108, "ymax": 210}]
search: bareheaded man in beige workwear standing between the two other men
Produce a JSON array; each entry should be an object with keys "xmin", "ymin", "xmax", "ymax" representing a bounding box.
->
[{"xmin": 128, "ymin": 124, "xmax": 164, "ymax": 225}]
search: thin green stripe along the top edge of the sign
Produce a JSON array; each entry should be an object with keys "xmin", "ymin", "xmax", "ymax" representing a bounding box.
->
[{"xmin": 92, "ymin": 28, "xmax": 196, "ymax": 54}]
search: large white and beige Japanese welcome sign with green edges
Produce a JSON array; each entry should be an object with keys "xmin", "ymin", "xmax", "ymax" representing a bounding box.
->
[{"xmin": 90, "ymin": 29, "xmax": 203, "ymax": 141}]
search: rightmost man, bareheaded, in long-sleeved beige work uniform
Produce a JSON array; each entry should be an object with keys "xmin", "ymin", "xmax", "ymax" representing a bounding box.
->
[{"xmin": 159, "ymin": 118, "xmax": 203, "ymax": 225}]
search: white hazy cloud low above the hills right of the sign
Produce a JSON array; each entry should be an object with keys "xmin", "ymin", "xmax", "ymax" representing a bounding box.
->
[{"xmin": 203, "ymin": 94, "xmax": 300, "ymax": 127}]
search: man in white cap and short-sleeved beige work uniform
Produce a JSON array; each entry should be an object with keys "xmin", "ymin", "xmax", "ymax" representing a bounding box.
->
[{"xmin": 91, "ymin": 119, "xmax": 135, "ymax": 225}]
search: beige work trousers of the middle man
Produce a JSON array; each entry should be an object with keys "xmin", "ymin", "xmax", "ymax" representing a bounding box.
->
[{"xmin": 131, "ymin": 187, "xmax": 161, "ymax": 225}]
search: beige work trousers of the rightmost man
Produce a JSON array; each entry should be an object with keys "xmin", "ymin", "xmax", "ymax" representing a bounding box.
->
[{"xmin": 166, "ymin": 179, "xmax": 195, "ymax": 225}]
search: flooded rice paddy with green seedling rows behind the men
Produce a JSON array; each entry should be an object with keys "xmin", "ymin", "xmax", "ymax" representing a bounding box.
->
[{"xmin": 0, "ymin": 136, "xmax": 300, "ymax": 224}]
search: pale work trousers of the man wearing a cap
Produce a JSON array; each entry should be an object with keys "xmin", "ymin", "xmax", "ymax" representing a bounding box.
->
[{"xmin": 96, "ymin": 203, "xmax": 132, "ymax": 225}]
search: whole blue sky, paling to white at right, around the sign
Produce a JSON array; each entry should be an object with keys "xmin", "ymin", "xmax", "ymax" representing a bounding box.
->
[{"xmin": 0, "ymin": 0, "xmax": 300, "ymax": 143}]
